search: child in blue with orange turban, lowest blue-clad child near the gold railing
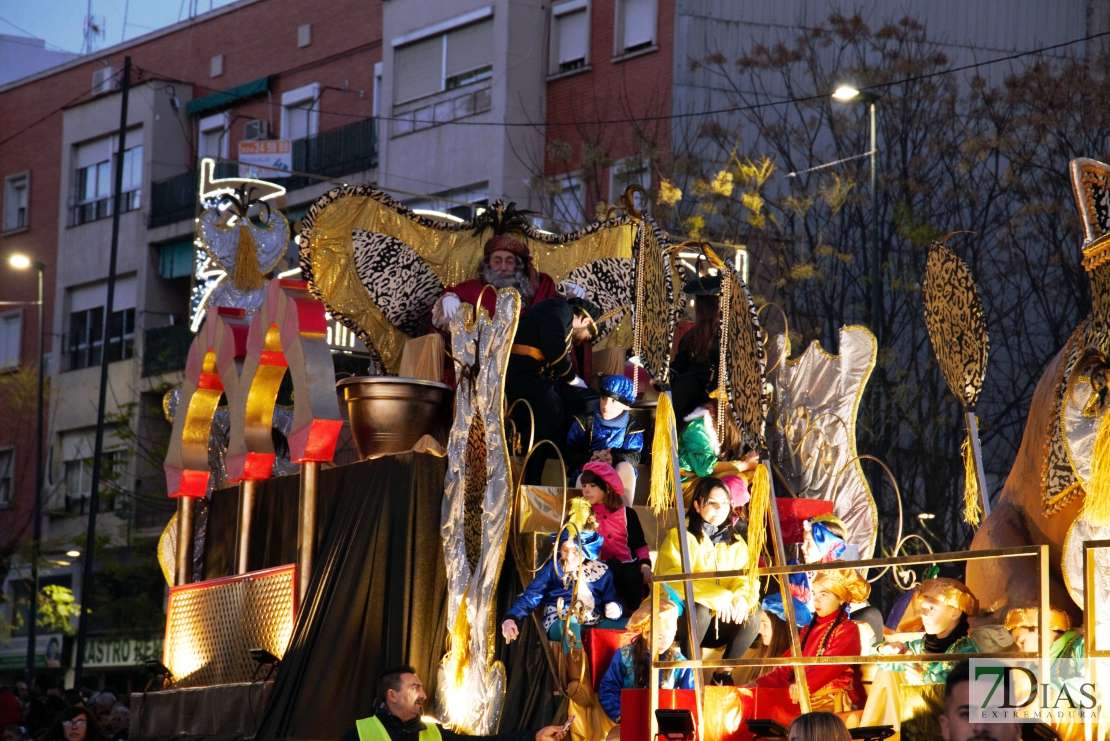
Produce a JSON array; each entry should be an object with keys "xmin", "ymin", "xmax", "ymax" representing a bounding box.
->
[{"xmin": 597, "ymin": 598, "xmax": 694, "ymax": 723}]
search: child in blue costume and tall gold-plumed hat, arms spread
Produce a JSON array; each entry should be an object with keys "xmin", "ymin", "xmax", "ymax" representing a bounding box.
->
[{"xmin": 501, "ymin": 498, "xmax": 624, "ymax": 646}]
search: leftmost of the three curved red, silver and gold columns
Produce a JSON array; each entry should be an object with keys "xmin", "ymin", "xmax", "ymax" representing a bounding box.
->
[{"xmin": 163, "ymin": 306, "xmax": 250, "ymax": 497}]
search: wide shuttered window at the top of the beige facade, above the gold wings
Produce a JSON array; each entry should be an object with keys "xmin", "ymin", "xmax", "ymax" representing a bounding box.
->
[{"xmin": 393, "ymin": 7, "xmax": 493, "ymax": 103}]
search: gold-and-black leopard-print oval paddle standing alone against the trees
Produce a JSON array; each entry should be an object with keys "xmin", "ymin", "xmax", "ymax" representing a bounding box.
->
[{"xmin": 921, "ymin": 242, "xmax": 990, "ymax": 410}]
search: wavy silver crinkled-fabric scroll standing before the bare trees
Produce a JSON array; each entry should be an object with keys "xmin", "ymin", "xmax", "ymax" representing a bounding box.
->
[{"xmin": 767, "ymin": 326, "xmax": 878, "ymax": 560}]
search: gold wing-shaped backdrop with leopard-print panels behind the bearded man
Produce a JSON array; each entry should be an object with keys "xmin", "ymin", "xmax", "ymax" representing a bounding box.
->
[{"xmin": 300, "ymin": 185, "xmax": 635, "ymax": 373}]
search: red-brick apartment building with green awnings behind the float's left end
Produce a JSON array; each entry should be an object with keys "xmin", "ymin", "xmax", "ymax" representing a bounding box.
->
[{"xmin": 0, "ymin": 0, "xmax": 382, "ymax": 684}]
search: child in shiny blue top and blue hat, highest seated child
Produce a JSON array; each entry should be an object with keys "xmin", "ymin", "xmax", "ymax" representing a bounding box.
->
[{"xmin": 566, "ymin": 376, "xmax": 644, "ymax": 505}]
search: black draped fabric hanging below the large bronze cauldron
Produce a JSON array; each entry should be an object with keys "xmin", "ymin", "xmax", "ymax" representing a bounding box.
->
[{"xmin": 252, "ymin": 453, "xmax": 450, "ymax": 739}]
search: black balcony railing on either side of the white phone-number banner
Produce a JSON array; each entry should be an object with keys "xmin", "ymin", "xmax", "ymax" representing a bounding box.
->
[{"xmin": 149, "ymin": 119, "xmax": 377, "ymax": 229}]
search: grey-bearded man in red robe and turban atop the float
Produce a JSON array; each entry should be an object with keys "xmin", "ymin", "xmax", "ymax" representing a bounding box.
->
[{"xmin": 432, "ymin": 234, "xmax": 586, "ymax": 332}]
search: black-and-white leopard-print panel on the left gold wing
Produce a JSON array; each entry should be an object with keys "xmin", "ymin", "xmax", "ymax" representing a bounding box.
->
[{"xmin": 351, "ymin": 230, "xmax": 443, "ymax": 337}]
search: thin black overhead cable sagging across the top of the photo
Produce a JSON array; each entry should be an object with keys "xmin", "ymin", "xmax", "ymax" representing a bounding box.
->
[{"xmin": 132, "ymin": 31, "xmax": 1110, "ymax": 129}]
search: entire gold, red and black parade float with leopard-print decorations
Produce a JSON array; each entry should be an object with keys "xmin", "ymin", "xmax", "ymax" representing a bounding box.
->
[{"xmin": 133, "ymin": 161, "xmax": 1110, "ymax": 741}]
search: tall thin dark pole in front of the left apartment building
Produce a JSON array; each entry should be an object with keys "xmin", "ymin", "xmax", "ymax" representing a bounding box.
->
[{"xmin": 73, "ymin": 57, "xmax": 131, "ymax": 687}]
